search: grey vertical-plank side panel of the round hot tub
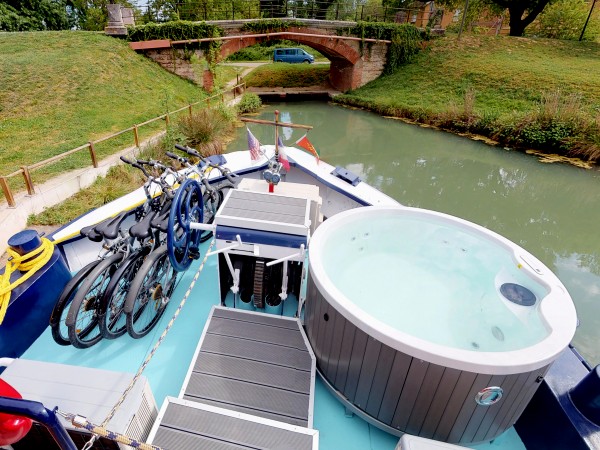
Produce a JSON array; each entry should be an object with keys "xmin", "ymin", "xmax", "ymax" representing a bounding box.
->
[{"xmin": 305, "ymin": 284, "xmax": 549, "ymax": 444}]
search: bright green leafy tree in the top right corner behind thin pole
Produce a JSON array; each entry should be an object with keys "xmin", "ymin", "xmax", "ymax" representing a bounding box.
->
[{"xmin": 529, "ymin": 0, "xmax": 600, "ymax": 41}]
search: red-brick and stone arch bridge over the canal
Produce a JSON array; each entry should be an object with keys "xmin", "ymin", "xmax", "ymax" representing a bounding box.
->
[{"xmin": 130, "ymin": 19, "xmax": 390, "ymax": 92}]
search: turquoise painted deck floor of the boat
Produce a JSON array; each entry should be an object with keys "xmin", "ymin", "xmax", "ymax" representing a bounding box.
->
[{"xmin": 23, "ymin": 246, "xmax": 525, "ymax": 450}]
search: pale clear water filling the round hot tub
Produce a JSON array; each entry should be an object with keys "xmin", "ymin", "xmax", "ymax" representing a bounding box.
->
[{"xmin": 323, "ymin": 217, "xmax": 548, "ymax": 352}]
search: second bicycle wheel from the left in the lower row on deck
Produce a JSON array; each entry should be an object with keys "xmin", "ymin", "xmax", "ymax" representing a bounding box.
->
[{"xmin": 66, "ymin": 253, "xmax": 123, "ymax": 348}]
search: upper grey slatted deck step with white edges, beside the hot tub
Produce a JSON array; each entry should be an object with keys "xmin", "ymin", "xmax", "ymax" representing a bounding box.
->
[{"xmin": 179, "ymin": 306, "xmax": 315, "ymax": 428}]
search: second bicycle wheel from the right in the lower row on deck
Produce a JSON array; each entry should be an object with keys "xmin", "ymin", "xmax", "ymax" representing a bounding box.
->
[{"xmin": 98, "ymin": 247, "xmax": 150, "ymax": 339}]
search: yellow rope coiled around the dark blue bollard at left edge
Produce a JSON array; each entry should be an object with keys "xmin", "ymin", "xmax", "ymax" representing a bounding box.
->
[{"xmin": 0, "ymin": 238, "xmax": 54, "ymax": 324}]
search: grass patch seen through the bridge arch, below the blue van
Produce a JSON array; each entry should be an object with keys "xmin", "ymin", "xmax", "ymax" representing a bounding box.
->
[{"xmin": 245, "ymin": 63, "xmax": 329, "ymax": 88}]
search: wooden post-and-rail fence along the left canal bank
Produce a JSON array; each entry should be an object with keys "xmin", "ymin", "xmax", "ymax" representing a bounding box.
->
[{"xmin": 0, "ymin": 78, "xmax": 246, "ymax": 208}]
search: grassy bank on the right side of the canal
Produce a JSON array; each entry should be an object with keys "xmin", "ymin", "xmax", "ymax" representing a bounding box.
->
[{"xmin": 338, "ymin": 36, "xmax": 600, "ymax": 161}]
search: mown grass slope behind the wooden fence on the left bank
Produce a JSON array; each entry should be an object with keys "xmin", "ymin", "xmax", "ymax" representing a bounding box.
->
[{"xmin": 0, "ymin": 31, "xmax": 206, "ymax": 192}]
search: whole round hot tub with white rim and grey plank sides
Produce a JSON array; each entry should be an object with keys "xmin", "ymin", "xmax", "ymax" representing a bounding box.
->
[{"xmin": 305, "ymin": 207, "xmax": 577, "ymax": 443}]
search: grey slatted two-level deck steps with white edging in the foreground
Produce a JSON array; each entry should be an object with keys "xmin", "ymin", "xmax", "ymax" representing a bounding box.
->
[{"xmin": 150, "ymin": 306, "xmax": 319, "ymax": 450}]
